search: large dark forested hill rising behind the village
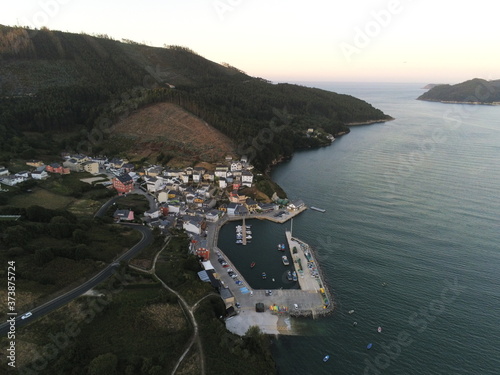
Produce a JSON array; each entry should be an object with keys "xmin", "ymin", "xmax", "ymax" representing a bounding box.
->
[{"xmin": 0, "ymin": 25, "xmax": 390, "ymax": 167}]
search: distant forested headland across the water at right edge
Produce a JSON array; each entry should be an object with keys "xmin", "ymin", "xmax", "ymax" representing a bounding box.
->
[{"xmin": 418, "ymin": 78, "xmax": 500, "ymax": 104}]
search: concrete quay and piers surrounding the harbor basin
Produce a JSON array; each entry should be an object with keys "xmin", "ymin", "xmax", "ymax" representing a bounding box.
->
[{"xmin": 207, "ymin": 206, "xmax": 334, "ymax": 336}]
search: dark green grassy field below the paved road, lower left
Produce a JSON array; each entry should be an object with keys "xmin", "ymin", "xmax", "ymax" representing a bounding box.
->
[{"xmin": 2, "ymin": 274, "xmax": 196, "ymax": 375}]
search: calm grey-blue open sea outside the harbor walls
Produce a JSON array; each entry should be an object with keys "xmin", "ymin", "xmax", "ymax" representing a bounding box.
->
[{"xmin": 262, "ymin": 82, "xmax": 500, "ymax": 375}]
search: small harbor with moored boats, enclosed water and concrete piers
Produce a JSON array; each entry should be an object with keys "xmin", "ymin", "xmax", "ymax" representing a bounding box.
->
[{"xmin": 205, "ymin": 208, "xmax": 333, "ymax": 335}]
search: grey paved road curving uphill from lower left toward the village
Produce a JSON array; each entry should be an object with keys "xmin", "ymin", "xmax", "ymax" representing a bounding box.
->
[{"xmin": 0, "ymin": 224, "xmax": 153, "ymax": 336}]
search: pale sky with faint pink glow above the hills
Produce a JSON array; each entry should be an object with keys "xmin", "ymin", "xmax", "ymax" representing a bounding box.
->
[{"xmin": 0, "ymin": 0, "xmax": 500, "ymax": 83}]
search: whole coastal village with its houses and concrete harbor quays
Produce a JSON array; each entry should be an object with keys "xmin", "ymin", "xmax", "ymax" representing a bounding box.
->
[{"xmin": 0, "ymin": 154, "xmax": 330, "ymax": 334}]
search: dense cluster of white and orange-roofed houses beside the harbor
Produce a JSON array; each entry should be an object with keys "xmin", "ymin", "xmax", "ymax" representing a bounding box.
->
[{"xmin": 113, "ymin": 157, "xmax": 275, "ymax": 236}]
